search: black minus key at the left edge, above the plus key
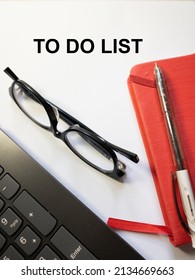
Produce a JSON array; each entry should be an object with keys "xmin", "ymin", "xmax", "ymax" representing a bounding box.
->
[{"xmin": 0, "ymin": 174, "xmax": 20, "ymax": 199}]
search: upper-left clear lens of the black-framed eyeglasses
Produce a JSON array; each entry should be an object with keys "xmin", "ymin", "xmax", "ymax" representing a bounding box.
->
[{"xmin": 13, "ymin": 83, "xmax": 50, "ymax": 127}]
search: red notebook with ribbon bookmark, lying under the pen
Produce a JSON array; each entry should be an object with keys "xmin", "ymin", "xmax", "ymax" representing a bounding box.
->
[{"xmin": 108, "ymin": 54, "xmax": 195, "ymax": 246}]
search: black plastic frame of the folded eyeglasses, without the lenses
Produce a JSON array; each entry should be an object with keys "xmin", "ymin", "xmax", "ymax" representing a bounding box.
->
[{"xmin": 4, "ymin": 67, "xmax": 139, "ymax": 179}]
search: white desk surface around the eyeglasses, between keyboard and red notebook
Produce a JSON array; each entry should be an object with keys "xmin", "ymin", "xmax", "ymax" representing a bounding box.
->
[{"xmin": 0, "ymin": 1, "xmax": 195, "ymax": 260}]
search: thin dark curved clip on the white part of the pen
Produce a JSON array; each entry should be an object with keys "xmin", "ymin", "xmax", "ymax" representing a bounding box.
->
[{"xmin": 171, "ymin": 172, "xmax": 191, "ymax": 236}]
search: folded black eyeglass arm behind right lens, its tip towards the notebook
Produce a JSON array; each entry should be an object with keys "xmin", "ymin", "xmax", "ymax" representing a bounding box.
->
[{"xmin": 55, "ymin": 103, "xmax": 139, "ymax": 163}]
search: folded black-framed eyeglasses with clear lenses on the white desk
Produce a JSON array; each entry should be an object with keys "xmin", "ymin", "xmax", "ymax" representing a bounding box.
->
[{"xmin": 4, "ymin": 67, "xmax": 139, "ymax": 179}]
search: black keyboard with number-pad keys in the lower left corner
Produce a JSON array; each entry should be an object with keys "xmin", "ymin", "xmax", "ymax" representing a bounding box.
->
[{"xmin": 0, "ymin": 130, "xmax": 143, "ymax": 260}]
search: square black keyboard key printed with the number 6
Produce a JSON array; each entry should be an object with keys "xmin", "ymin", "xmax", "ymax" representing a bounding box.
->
[{"xmin": 16, "ymin": 227, "xmax": 41, "ymax": 256}]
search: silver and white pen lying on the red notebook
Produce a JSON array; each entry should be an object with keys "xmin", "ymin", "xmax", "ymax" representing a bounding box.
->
[{"xmin": 154, "ymin": 63, "xmax": 195, "ymax": 248}]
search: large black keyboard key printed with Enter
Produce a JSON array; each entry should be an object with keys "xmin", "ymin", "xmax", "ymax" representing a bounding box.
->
[{"xmin": 50, "ymin": 227, "xmax": 96, "ymax": 260}]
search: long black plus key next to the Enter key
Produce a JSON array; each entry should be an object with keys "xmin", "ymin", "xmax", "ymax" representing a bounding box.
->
[{"xmin": 13, "ymin": 191, "xmax": 56, "ymax": 235}]
